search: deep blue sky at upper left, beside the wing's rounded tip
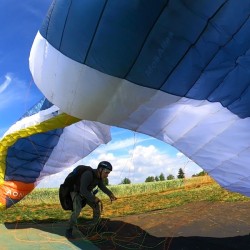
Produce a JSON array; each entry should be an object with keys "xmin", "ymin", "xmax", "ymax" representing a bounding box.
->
[{"xmin": 0, "ymin": 0, "xmax": 51, "ymax": 135}]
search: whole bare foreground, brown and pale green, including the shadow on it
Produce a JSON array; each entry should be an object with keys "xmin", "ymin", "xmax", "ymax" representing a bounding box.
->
[{"xmin": 0, "ymin": 202, "xmax": 250, "ymax": 250}]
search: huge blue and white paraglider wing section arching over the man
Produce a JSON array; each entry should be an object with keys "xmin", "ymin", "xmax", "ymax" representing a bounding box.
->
[{"xmin": 30, "ymin": 0, "xmax": 250, "ymax": 196}]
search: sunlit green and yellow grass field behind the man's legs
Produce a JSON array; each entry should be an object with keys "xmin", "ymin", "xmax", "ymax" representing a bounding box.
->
[{"xmin": 0, "ymin": 176, "xmax": 250, "ymax": 223}]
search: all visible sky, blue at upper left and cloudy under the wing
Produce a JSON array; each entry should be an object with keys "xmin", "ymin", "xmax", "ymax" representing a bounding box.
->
[{"xmin": 0, "ymin": 0, "xmax": 202, "ymax": 187}]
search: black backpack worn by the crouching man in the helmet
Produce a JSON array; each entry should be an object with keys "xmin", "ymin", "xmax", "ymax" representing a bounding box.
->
[{"xmin": 59, "ymin": 165, "xmax": 93, "ymax": 211}]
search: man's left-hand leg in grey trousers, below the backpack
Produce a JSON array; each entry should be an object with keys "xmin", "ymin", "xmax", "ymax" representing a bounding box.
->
[{"xmin": 66, "ymin": 192, "xmax": 82, "ymax": 239}]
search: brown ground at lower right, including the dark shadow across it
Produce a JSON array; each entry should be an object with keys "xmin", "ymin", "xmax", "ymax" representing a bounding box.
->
[{"xmin": 78, "ymin": 202, "xmax": 250, "ymax": 250}]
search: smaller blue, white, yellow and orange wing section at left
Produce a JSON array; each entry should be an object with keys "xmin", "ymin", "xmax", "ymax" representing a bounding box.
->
[{"xmin": 0, "ymin": 99, "xmax": 111, "ymax": 210}]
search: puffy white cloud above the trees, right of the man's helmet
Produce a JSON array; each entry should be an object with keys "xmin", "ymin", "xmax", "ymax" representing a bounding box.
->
[{"xmin": 107, "ymin": 145, "xmax": 202, "ymax": 184}]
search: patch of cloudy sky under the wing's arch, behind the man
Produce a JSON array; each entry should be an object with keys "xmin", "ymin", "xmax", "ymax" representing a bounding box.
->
[{"xmin": 36, "ymin": 130, "xmax": 205, "ymax": 186}]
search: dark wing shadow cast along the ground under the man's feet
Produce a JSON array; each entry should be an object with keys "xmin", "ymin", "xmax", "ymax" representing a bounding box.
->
[{"xmin": 5, "ymin": 219, "xmax": 250, "ymax": 250}]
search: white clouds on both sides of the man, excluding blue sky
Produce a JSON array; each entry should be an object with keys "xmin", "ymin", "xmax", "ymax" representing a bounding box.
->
[{"xmin": 37, "ymin": 142, "xmax": 202, "ymax": 186}]
